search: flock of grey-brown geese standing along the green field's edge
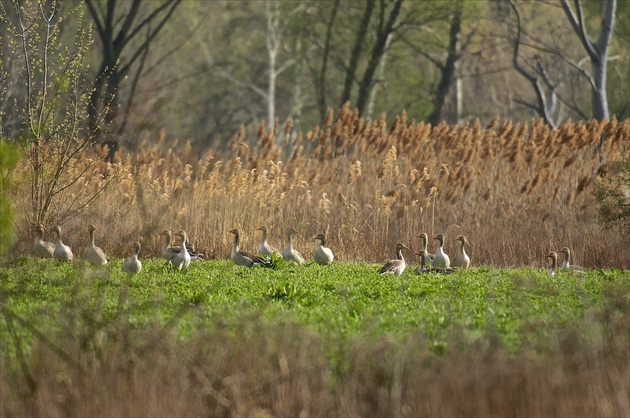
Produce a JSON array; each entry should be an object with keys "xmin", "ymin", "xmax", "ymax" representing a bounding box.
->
[{"xmin": 34, "ymin": 224, "xmax": 581, "ymax": 276}]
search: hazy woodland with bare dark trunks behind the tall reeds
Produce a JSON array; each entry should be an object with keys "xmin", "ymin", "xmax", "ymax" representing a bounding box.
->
[{"xmin": 0, "ymin": 0, "xmax": 630, "ymax": 154}]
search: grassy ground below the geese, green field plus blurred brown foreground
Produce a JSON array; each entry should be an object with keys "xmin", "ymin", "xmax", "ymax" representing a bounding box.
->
[{"xmin": 0, "ymin": 258, "xmax": 630, "ymax": 416}]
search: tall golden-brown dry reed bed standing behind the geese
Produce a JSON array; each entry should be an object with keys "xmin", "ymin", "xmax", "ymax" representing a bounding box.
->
[{"xmin": 8, "ymin": 107, "xmax": 630, "ymax": 269}]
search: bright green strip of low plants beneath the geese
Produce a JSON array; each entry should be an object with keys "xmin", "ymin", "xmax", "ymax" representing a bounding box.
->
[{"xmin": 2, "ymin": 259, "xmax": 630, "ymax": 353}]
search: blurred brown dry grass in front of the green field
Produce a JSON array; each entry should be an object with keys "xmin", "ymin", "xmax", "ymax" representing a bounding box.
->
[{"xmin": 2, "ymin": 312, "xmax": 630, "ymax": 417}]
